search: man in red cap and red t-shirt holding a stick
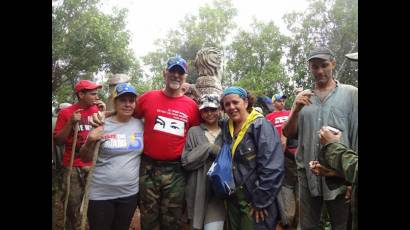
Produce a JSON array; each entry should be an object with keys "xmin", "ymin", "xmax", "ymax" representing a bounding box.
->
[{"xmin": 53, "ymin": 80, "xmax": 105, "ymax": 230}]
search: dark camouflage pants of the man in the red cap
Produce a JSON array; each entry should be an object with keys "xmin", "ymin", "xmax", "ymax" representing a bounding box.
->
[{"xmin": 62, "ymin": 167, "xmax": 89, "ymax": 230}]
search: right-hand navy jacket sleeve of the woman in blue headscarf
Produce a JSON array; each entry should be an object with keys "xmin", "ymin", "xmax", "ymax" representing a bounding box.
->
[{"xmin": 252, "ymin": 119, "xmax": 284, "ymax": 208}]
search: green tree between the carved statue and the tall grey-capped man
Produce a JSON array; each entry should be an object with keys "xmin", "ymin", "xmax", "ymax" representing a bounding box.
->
[{"xmin": 223, "ymin": 19, "xmax": 290, "ymax": 96}]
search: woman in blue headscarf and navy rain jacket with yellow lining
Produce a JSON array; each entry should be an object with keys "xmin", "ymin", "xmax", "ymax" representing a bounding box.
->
[{"xmin": 221, "ymin": 87, "xmax": 284, "ymax": 230}]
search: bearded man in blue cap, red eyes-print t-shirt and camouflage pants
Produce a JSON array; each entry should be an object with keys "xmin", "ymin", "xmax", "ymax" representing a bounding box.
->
[{"xmin": 134, "ymin": 57, "xmax": 199, "ymax": 230}]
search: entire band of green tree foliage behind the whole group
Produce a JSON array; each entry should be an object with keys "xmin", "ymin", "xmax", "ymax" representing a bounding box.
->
[{"xmin": 52, "ymin": 0, "xmax": 358, "ymax": 108}]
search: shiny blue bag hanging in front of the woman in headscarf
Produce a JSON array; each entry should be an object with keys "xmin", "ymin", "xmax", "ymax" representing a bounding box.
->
[{"xmin": 207, "ymin": 142, "xmax": 235, "ymax": 198}]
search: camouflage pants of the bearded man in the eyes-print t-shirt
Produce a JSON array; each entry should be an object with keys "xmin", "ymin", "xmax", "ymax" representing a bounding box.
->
[{"xmin": 139, "ymin": 156, "xmax": 186, "ymax": 230}]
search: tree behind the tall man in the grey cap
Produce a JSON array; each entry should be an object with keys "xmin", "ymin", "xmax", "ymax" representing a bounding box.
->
[{"xmin": 284, "ymin": 0, "xmax": 358, "ymax": 88}]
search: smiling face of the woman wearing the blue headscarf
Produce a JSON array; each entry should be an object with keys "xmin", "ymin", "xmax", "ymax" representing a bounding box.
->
[{"xmin": 222, "ymin": 94, "xmax": 248, "ymax": 123}]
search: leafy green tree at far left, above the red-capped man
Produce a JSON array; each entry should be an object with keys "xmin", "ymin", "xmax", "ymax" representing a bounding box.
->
[{"xmin": 52, "ymin": 0, "xmax": 142, "ymax": 102}]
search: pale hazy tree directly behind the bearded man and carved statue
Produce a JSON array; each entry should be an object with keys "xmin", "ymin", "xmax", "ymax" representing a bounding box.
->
[{"xmin": 143, "ymin": 0, "xmax": 237, "ymax": 88}]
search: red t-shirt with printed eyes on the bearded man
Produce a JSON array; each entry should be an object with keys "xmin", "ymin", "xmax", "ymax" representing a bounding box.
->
[{"xmin": 134, "ymin": 90, "xmax": 199, "ymax": 160}]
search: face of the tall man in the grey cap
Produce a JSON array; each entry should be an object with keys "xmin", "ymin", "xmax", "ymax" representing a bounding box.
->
[{"xmin": 309, "ymin": 58, "xmax": 336, "ymax": 85}]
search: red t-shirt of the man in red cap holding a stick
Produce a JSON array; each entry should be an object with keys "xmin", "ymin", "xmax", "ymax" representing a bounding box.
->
[{"xmin": 54, "ymin": 104, "xmax": 98, "ymax": 167}]
